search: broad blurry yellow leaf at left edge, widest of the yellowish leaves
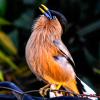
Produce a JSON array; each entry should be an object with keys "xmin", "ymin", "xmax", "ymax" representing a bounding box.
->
[{"xmin": 0, "ymin": 32, "xmax": 17, "ymax": 55}]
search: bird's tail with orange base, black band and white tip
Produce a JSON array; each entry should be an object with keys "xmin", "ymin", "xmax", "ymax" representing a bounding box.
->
[{"xmin": 63, "ymin": 76, "xmax": 98, "ymax": 100}]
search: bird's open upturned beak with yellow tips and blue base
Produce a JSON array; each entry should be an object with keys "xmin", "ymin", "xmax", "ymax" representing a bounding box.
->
[{"xmin": 39, "ymin": 4, "xmax": 53, "ymax": 20}]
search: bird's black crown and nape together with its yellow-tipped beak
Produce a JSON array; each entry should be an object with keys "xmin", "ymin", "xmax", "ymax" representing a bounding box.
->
[{"xmin": 39, "ymin": 4, "xmax": 67, "ymax": 33}]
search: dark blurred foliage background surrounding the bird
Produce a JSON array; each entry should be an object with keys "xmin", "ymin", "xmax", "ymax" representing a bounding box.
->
[{"xmin": 0, "ymin": 0, "xmax": 100, "ymax": 96}]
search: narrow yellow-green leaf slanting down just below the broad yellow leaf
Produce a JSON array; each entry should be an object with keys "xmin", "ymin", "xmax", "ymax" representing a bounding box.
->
[{"xmin": 0, "ymin": 50, "xmax": 18, "ymax": 70}]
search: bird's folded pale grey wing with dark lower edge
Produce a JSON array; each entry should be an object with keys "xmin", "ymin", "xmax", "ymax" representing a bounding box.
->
[{"xmin": 53, "ymin": 40, "xmax": 75, "ymax": 67}]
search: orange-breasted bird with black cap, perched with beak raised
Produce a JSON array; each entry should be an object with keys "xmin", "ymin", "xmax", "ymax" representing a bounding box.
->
[{"xmin": 25, "ymin": 4, "xmax": 96, "ymax": 99}]
